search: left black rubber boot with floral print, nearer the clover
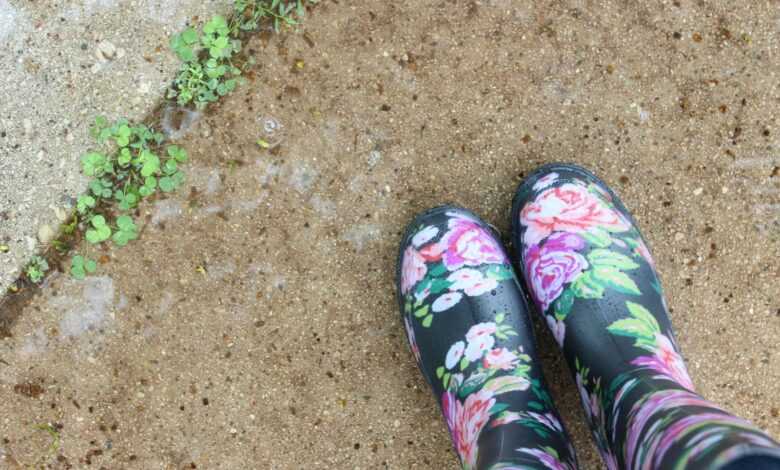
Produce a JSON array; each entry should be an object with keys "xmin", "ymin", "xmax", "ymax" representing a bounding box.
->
[{"xmin": 398, "ymin": 206, "xmax": 576, "ymax": 470}]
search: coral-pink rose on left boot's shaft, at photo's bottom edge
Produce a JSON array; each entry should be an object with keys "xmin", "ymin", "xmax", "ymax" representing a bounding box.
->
[{"xmin": 441, "ymin": 390, "xmax": 496, "ymax": 469}]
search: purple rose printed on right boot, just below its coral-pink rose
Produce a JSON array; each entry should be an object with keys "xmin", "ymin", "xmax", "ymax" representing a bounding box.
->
[{"xmin": 525, "ymin": 233, "xmax": 588, "ymax": 312}]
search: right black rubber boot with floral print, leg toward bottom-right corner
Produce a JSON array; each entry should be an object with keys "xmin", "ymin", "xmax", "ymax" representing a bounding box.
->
[{"xmin": 512, "ymin": 164, "xmax": 780, "ymax": 470}]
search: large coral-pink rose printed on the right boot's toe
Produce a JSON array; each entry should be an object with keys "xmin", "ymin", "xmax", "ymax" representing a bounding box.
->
[{"xmin": 520, "ymin": 183, "xmax": 630, "ymax": 246}]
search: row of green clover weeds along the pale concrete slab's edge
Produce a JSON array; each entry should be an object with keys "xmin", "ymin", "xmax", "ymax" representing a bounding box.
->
[{"xmin": 53, "ymin": 0, "xmax": 318, "ymax": 283}]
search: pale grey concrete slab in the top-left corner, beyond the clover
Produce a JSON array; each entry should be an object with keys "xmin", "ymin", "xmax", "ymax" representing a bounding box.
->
[{"xmin": 0, "ymin": 0, "xmax": 232, "ymax": 295}]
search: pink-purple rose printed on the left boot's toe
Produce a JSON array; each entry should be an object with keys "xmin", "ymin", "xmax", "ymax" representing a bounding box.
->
[{"xmin": 439, "ymin": 216, "xmax": 507, "ymax": 271}]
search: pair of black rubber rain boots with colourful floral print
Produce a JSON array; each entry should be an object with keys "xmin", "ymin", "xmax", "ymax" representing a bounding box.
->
[{"xmin": 397, "ymin": 164, "xmax": 780, "ymax": 470}]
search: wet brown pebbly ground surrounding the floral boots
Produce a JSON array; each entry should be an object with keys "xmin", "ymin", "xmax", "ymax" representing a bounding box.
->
[{"xmin": 0, "ymin": 0, "xmax": 780, "ymax": 469}]
